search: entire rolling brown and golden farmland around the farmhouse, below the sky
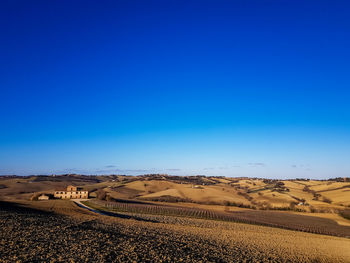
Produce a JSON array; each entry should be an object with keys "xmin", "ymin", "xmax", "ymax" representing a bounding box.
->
[{"xmin": 0, "ymin": 175, "xmax": 350, "ymax": 262}]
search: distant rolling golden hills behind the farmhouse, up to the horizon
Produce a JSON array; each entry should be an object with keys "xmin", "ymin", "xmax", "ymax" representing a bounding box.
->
[{"xmin": 0, "ymin": 175, "xmax": 350, "ymax": 212}]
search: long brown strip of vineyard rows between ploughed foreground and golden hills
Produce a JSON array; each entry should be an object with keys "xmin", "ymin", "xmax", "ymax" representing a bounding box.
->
[{"xmin": 86, "ymin": 200, "xmax": 350, "ymax": 238}]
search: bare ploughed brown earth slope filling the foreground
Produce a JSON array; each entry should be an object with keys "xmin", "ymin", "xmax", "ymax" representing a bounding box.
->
[{"xmin": 0, "ymin": 200, "xmax": 350, "ymax": 262}]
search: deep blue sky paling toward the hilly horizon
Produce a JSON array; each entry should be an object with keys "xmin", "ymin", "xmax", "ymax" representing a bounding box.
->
[{"xmin": 0, "ymin": 0, "xmax": 350, "ymax": 178}]
